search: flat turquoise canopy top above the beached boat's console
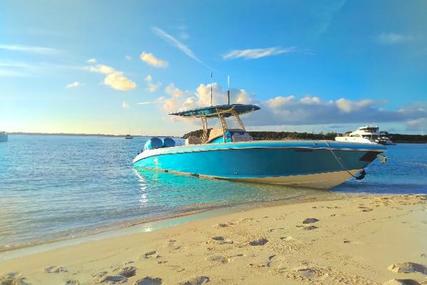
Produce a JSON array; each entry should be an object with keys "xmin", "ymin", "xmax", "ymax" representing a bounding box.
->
[{"xmin": 169, "ymin": 104, "xmax": 260, "ymax": 118}]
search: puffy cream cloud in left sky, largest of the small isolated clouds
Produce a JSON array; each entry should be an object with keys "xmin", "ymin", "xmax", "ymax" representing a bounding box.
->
[{"xmin": 86, "ymin": 61, "xmax": 136, "ymax": 91}]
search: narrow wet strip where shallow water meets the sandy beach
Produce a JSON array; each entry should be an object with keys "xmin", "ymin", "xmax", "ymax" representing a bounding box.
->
[{"xmin": 0, "ymin": 190, "xmax": 342, "ymax": 262}]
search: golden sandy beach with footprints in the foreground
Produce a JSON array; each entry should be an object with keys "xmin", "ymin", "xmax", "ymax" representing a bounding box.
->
[{"xmin": 0, "ymin": 195, "xmax": 427, "ymax": 285}]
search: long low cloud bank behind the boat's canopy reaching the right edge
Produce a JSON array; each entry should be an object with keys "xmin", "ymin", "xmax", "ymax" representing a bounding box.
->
[{"xmin": 157, "ymin": 83, "xmax": 427, "ymax": 130}]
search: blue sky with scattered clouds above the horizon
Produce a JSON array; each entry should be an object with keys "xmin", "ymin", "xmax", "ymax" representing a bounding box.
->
[{"xmin": 0, "ymin": 0, "xmax": 427, "ymax": 135}]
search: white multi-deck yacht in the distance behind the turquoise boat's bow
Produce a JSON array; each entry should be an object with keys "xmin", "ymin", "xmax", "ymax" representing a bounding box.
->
[{"xmin": 335, "ymin": 125, "xmax": 393, "ymax": 145}]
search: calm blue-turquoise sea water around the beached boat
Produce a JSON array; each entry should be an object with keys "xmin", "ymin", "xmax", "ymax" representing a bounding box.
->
[{"xmin": 0, "ymin": 135, "xmax": 427, "ymax": 249}]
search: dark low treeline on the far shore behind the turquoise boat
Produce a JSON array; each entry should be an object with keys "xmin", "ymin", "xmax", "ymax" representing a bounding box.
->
[{"xmin": 183, "ymin": 129, "xmax": 427, "ymax": 143}]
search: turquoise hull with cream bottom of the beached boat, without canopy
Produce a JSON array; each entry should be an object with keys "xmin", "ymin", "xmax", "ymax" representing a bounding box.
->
[{"xmin": 133, "ymin": 141, "xmax": 384, "ymax": 189}]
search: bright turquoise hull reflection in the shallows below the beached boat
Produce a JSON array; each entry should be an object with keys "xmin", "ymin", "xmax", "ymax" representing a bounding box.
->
[{"xmin": 135, "ymin": 166, "xmax": 330, "ymax": 209}]
